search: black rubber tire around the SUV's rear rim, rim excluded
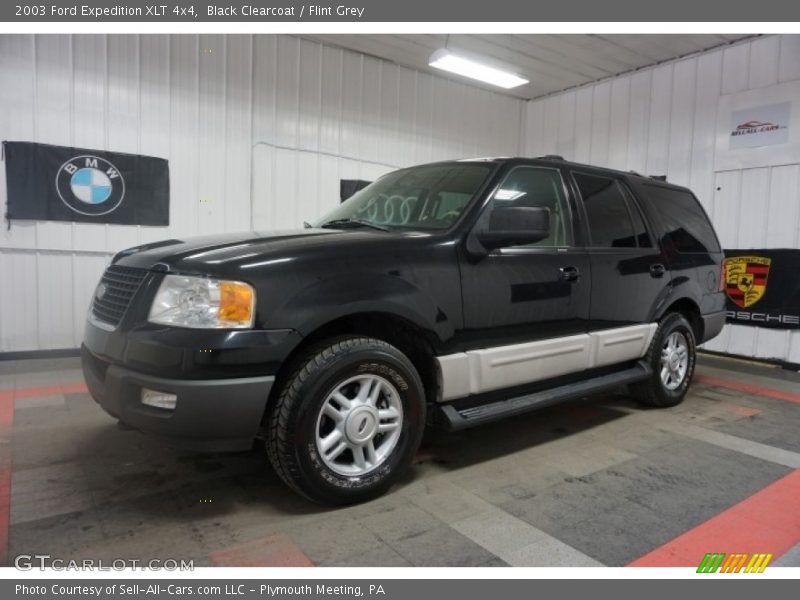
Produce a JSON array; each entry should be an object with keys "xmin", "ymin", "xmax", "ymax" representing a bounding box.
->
[{"xmin": 630, "ymin": 313, "xmax": 696, "ymax": 408}]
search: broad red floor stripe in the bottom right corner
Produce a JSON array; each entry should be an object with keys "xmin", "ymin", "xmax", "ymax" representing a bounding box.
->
[{"xmin": 628, "ymin": 469, "xmax": 800, "ymax": 567}]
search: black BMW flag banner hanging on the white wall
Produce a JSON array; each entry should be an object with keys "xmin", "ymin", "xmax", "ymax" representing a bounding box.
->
[{"xmin": 3, "ymin": 142, "xmax": 169, "ymax": 226}]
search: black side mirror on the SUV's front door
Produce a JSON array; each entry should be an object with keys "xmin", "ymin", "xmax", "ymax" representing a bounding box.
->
[{"xmin": 475, "ymin": 206, "xmax": 550, "ymax": 250}]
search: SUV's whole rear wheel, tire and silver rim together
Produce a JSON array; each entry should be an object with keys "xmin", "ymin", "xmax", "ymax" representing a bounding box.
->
[{"xmin": 630, "ymin": 313, "xmax": 696, "ymax": 407}]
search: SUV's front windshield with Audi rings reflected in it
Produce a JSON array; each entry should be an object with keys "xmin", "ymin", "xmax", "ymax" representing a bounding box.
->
[{"xmin": 315, "ymin": 163, "xmax": 493, "ymax": 230}]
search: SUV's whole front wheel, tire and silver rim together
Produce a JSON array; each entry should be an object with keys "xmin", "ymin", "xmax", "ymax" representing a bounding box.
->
[{"xmin": 267, "ymin": 337, "xmax": 425, "ymax": 504}]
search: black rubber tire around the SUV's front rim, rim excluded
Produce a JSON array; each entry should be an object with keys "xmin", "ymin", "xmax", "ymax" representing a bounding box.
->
[{"xmin": 266, "ymin": 337, "xmax": 425, "ymax": 505}]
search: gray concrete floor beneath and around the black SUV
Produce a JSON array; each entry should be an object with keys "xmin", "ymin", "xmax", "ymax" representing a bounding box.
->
[{"xmin": 0, "ymin": 358, "xmax": 800, "ymax": 566}]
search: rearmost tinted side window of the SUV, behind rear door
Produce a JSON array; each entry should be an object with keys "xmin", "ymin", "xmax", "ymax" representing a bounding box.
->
[{"xmin": 643, "ymin": 185, "xmax": 720, "ymax": 253}]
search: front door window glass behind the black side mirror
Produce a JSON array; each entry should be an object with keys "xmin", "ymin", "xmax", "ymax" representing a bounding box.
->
[{"xmin": 484, "ymin": 167, "xmax": 572, "ymax": 247}]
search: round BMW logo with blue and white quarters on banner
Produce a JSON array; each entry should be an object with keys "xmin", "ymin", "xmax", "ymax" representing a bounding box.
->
[{"xmin": 56, "ymin": 155, "xmax": 125, "ymax": 217}]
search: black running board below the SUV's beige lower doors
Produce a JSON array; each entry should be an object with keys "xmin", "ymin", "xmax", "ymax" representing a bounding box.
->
[{"xmin": 439, "ymin": 361, "xmax": 653, "ymax": 431}]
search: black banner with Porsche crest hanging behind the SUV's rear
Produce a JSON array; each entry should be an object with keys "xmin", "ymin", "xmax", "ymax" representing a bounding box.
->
[{"xmin": 724, "ymin": 249, "xmax": 800, "ymax": 329}]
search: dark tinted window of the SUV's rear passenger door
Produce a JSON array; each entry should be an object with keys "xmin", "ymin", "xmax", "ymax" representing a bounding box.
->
[{"xmin": 572, "ymin": 173, "xmax": 641, "ymax": 248}]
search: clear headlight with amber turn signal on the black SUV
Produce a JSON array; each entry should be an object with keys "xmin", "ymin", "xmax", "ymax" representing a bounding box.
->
[{"xmin": 148, "ymin": 275, "xmax": 256, "ymax": 329}]
